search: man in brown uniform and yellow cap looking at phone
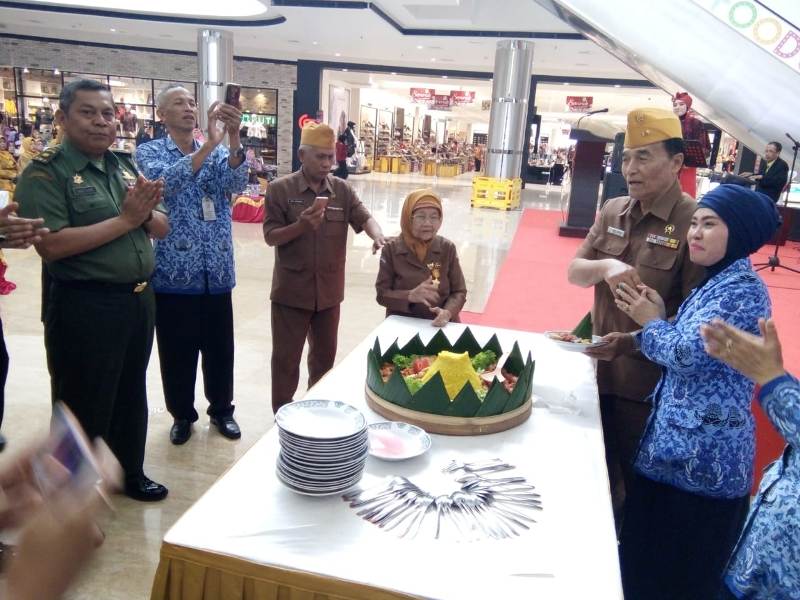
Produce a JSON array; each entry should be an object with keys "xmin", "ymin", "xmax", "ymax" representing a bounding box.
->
[{"xmin": 264, "ymin": 123, "xmax": 384, "ymax": 412}]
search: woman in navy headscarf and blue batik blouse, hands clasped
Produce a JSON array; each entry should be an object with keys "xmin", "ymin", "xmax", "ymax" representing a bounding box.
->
[{"xmin": 615, "ymin": 185, "xmax": 779, "ymax": 600}]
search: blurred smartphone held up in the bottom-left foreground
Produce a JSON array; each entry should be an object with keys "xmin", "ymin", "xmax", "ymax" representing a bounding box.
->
[{"xmin": 32, "ymin": 402, "xmax": 103, "ymax": 496}]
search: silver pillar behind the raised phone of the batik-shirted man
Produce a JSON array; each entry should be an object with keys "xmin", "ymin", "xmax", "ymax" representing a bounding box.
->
[{"xmin": 197, "ymin": 29, "xmax": 233, "ymax": 131}]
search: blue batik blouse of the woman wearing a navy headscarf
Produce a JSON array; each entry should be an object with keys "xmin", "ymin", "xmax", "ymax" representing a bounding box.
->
[{"xmin": 635, "ymin": 258, "xmax": 770, "ymax": 498}]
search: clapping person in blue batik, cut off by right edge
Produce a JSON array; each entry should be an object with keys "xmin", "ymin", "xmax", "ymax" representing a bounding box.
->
[{"xmin": 701, "ymin": 320, "xmax": 800, "ymax": 600}]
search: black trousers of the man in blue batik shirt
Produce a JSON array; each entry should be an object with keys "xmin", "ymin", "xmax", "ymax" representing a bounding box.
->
[{"xmin": 156, "ymin": 292, "xmax": 233, "ymax": 422}]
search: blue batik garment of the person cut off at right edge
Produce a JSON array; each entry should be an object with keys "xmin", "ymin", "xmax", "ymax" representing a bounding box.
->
[{"xmin": 725, "ymin": 375, "xmax": 800, "ymax": 600}]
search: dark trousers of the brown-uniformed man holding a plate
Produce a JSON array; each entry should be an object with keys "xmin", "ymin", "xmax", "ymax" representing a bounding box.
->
[{"xmin": 600, "ymin": 394, "xmax": 652, "ymax": 530}]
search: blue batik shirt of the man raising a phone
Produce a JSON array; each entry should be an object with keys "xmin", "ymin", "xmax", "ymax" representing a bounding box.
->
[{"xmin": 136, "ymin": 137, "xmax": 247, "ymax": 294}]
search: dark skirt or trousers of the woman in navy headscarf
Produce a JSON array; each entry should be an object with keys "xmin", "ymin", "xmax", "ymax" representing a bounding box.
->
[{"xmin": 620, "ymin": 475, "xmax": 750, "ymax": 600}]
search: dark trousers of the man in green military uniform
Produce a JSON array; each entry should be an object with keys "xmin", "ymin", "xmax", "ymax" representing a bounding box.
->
[{"xmin": 45, "ymin": 282, "xmax": 155, "ymax": 478}]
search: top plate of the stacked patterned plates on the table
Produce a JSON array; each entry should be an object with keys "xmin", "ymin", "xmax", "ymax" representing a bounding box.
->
[{"xmin": 275, "ymin": 400, "xmax": 366, "ymax": 440}]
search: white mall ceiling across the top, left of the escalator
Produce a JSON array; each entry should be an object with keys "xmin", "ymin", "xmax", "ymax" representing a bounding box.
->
[{"xmin": 0, "ymin": 0, "xmax": 640, "ymax": 79}]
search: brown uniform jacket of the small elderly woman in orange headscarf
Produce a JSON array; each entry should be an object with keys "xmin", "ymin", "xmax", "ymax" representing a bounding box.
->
[{"xmin": 375, "ymin": 235, "xmax": 467, "ymax": 323}]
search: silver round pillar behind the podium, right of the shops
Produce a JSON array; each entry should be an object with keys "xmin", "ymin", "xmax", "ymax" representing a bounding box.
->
[{"xmin": 486, "ymin": 40, "xmax": 533, "ymax": 179}]
